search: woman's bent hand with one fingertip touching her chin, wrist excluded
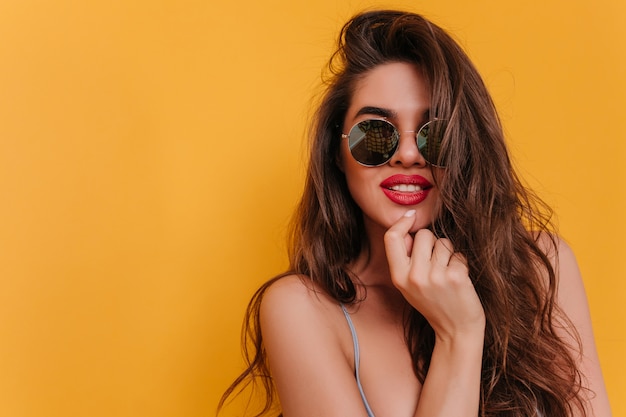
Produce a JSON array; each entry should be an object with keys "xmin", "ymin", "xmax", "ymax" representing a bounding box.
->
[{"xmin": 385, "ymin": 210, "xmax": 485, "ymax": 343}]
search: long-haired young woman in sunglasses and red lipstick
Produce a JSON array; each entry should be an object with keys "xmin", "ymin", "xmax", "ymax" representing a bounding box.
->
[{"xmin": 222, "ymin": 11, "xmax": 611, "ymax": 417}]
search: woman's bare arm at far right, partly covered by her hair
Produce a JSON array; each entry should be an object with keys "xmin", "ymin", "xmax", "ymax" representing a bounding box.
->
[{"xmin": 553, "ymin": 237, "xmax": 611, "ymax": 417}]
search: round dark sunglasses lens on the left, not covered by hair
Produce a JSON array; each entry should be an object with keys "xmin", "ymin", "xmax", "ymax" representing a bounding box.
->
[{"xmin": 348, "ymin": 120, "xmax": 399, "ymax": 166}]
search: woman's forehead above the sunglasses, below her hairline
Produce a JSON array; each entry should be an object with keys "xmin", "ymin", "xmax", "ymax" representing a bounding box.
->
[{"xmin": 346, "ymin": 62, "xmax": 430, "ymax": 120}]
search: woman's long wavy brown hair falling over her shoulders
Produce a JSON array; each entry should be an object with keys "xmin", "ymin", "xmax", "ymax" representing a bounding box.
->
[{"xmin": 218, "ymin": 11, "xmax": 585, "ymax": 417}]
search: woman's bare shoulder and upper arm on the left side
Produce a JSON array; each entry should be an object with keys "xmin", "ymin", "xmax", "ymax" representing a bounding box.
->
[{"xmin": 261, "ymin": 276, "xmax": 367, "ymax": 417}]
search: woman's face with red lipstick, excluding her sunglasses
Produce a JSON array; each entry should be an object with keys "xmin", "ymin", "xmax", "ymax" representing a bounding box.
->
[{"xmin": 339, "ymin": 62, "xmax": 439, "ymax": 236}]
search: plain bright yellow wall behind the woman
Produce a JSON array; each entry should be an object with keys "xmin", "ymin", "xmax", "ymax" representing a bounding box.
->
[{"xmin": 0, "ymin": 0, "xmax": 626, "ymax": 417}]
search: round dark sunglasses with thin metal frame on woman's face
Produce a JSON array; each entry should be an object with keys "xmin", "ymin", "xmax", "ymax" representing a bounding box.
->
[{"xmin": 341, "ymin": 119, "xmax": 447, "ymax": 168}]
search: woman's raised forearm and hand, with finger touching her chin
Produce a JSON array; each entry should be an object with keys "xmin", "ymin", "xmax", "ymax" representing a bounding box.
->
[{"xmin": 385, "ymin": 211, "xmax": 485, "ymax": 417}]
